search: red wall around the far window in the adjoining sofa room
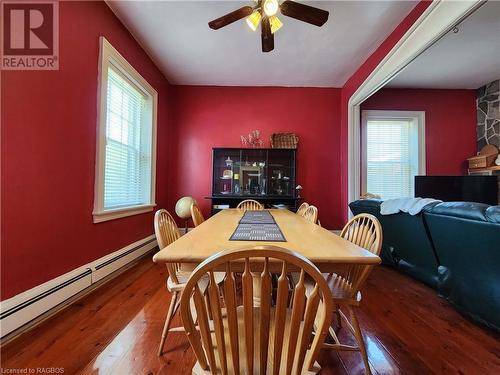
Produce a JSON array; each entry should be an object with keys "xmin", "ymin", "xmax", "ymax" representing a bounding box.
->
[{"xmin": 361, "ymin": 89, "xmax": 476, "ymax": 175}]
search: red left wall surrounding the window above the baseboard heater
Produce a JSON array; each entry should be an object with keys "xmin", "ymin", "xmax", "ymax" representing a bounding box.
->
[{"xmin": 1, "ymin": 2, "xmax": 171, "ymax": 299}]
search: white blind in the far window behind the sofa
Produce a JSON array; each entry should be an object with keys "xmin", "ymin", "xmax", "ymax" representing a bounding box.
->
[{"xmin": 366, "ymin": 119, "xmax": 419, "ymax": 199}]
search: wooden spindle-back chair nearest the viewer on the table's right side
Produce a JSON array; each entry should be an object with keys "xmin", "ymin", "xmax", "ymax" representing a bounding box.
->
[{"xmin": 316, "ymin": 214, "xmax": 382, "ymax": 374}]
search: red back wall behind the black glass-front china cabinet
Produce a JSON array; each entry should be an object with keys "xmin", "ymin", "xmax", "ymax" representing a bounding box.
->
[{"xmin": 169, "ymin": 86, "xmax": 342, "ymax": 228}]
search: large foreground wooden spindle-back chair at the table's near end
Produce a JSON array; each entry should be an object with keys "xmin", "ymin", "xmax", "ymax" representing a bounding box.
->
[{"xmin": 181, "ymin": 246, "xmax": 334, "ymax": 375}]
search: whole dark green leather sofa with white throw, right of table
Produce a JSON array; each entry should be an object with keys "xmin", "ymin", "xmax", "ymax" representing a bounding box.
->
[{"xmin": 349, "ymin": 200, "xmax": 500, "ymax": 332}]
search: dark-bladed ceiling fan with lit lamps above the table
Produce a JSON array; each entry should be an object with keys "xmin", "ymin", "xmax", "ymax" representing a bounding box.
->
[{"xmin": 208, "ymin": 0, "xmax": 329, "ymax": 52}]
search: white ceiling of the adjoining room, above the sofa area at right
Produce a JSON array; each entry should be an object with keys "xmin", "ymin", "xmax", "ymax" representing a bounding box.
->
[{"xmin": 387, "ymin": 1, "xmax": 500, "ymax": 89}]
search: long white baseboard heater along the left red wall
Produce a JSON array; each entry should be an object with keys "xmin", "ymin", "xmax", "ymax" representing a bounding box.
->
[{"xmin": 0, "ymin": 235, "xmax": 156, "ymax": 340}]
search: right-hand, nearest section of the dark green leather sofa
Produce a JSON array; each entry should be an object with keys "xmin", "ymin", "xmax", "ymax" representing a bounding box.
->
[{"xmin": 424, "ymin": 202, "xmax": 500, "ymax": 331}]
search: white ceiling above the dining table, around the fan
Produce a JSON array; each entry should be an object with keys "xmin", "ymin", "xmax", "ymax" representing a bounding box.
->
[{"xmin": 107, "ymin": 0, "xmax": 417, "ymax": 87}]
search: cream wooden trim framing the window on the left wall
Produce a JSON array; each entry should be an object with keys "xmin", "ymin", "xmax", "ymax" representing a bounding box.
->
[{"xmin": 92, "ymin": 36, "xmax": 158, "ymax": 223}]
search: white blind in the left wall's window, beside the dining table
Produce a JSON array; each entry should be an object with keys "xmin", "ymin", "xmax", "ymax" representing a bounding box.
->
[{"xmin": 104, "ymin": 66, "xmax": 151, "ymax": 209}]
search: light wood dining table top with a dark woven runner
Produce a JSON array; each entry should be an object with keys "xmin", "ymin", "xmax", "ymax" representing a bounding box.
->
[{"xmin": 153, "ymin": 209, "xmax": 381, "ymax": 273}]
